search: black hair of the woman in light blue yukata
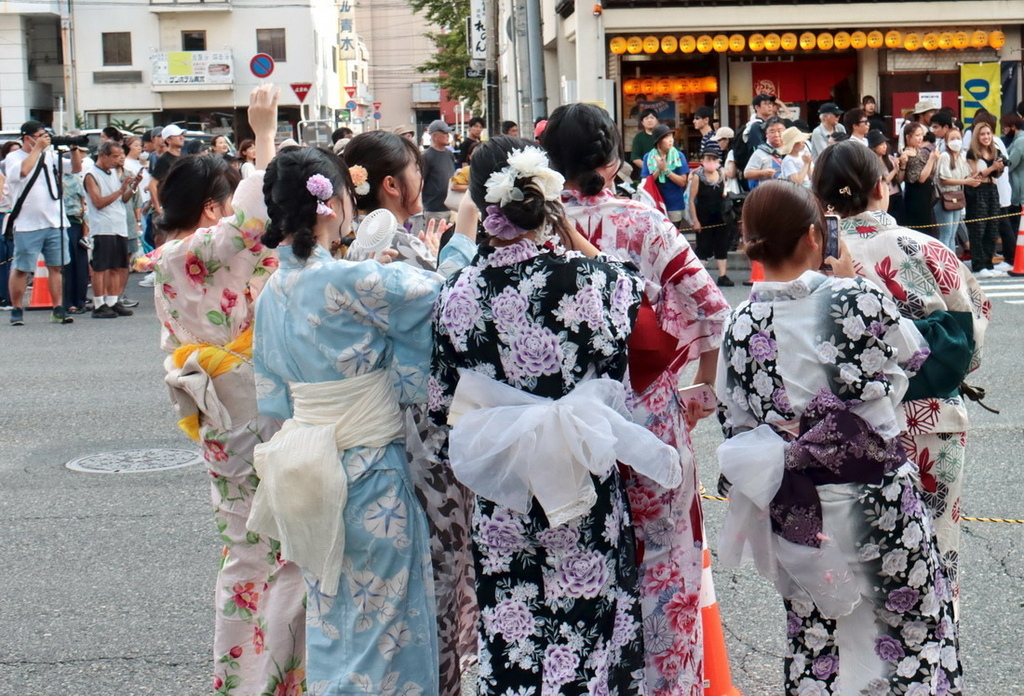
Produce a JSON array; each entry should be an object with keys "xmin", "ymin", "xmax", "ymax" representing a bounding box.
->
[{"xmin": 262, "ymin": 146, "xmax": 352, "ymax": 260}]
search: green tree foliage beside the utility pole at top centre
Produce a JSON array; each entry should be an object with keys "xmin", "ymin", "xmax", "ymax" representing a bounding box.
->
[{"xmin": 409, "ymin": 0, "xmax": 483, "ymax": 111}]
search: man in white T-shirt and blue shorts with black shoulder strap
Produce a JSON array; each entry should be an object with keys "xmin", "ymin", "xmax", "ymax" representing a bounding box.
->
[{"xmin": 4, "ymin": 121, "xmax": 82, "ymax": 327}]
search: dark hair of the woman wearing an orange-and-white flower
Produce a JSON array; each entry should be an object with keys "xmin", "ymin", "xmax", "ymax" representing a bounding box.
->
[{"xmin": 345, "ymin": 131, "xmax": 423, "ymax": 213}]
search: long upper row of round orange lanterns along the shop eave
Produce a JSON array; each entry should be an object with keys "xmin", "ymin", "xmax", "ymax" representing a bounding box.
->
[{"xmin": 608, "ymin": 30, "xmax": 1007, "ymax": 55}]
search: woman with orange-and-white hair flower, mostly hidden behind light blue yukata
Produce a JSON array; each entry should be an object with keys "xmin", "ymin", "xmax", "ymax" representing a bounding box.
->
[{"xmin": 345, "ymin": 131, "xmax": 478, "ymax": 696}]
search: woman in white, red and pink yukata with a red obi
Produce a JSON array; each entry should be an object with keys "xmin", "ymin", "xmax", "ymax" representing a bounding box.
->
[{"xmin": 544, "ymin": 104, "xmax": 729, "ymax": 696}]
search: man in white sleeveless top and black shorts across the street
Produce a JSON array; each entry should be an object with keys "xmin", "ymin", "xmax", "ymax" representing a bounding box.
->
[{"xmin": 85, "ymin": 140, "xmax": 142, "ymax": 319}]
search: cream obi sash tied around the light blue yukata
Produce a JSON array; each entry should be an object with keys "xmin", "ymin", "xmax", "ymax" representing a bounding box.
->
[{"xmin": 246, "ymin": 369, "xmax": 403, "ymax": 596}]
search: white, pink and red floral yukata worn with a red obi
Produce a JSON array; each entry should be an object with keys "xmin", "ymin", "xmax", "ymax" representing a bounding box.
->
[{"xmin": 562, "ymin": 190, "xmax": 729, "ymax": 696}]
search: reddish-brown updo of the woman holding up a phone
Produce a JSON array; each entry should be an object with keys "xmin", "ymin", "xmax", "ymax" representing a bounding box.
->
[{"xmin": 742, "ymin": 179, "xmax": 827, "ymax": 266}]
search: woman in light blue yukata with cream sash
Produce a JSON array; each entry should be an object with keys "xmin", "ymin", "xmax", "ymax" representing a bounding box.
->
[{"xmin": 249, "ymin": 141, "xmax": 475, "ymax": 696}]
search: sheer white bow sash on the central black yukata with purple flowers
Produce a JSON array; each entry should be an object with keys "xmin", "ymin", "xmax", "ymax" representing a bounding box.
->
[{"xmin": 449, "ymin": 369, "xmax": 682, "ymax": 527}]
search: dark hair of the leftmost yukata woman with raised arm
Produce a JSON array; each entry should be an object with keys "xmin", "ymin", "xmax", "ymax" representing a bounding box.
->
[{"xmin": 154, "ymin": 154, "xmax": 242, "ymax": 234}]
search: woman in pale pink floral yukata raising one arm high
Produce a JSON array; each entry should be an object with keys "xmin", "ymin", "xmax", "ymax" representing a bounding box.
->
[{"xmin": 151, "ymin": 86, "xmax": 305, "ymax": 696}]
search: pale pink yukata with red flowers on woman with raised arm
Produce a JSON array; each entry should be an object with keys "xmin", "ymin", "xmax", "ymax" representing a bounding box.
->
[{"xmin": 154, "ymin": 172, "xmax": 305, "ymax": 696}]
